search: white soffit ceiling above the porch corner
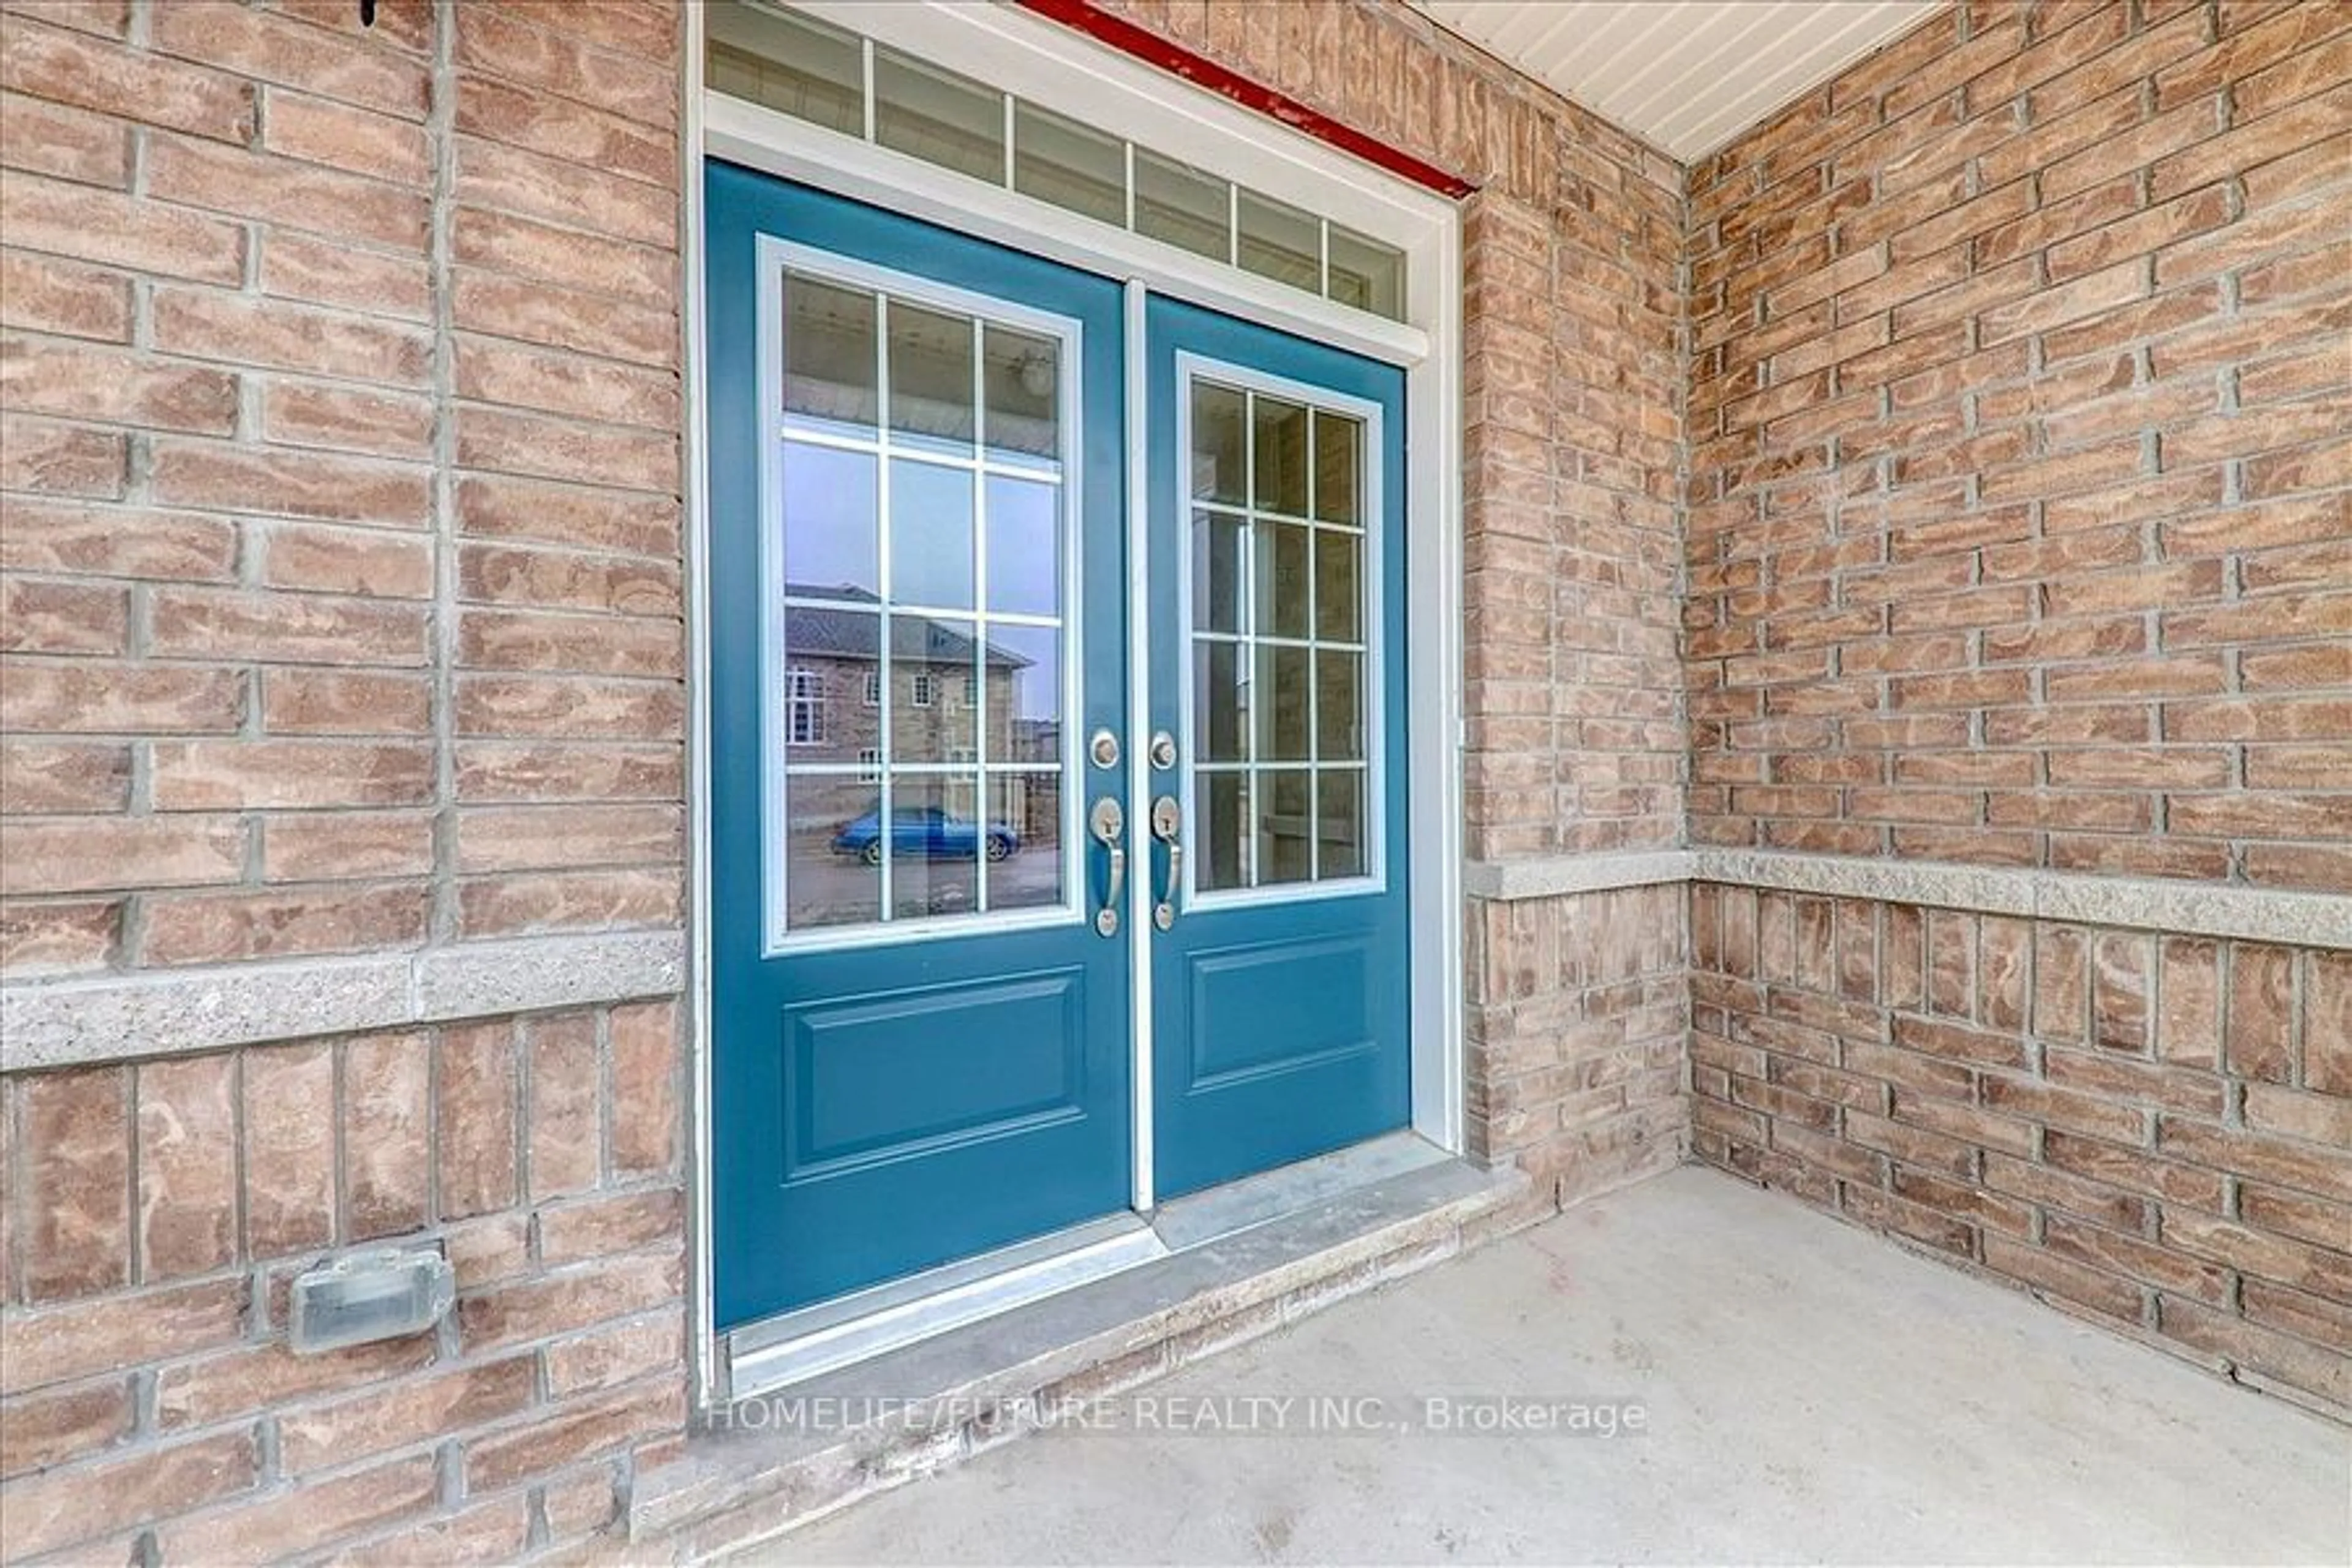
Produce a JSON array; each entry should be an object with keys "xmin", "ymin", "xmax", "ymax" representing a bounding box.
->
[{"xmin": 1416, "ymin": 0, "xmax": 1943, "ymax": 162}]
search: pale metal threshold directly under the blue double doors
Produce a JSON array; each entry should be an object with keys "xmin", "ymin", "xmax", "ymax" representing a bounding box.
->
[{"xmin": 725, "ymin": 1131, "xmax": 1451, "ymax": 1399}]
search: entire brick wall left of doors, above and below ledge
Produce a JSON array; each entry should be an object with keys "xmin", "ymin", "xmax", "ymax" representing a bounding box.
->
[{"xmin": 0, "ymin": 0, "xmax": 687, "ymax": 1561}]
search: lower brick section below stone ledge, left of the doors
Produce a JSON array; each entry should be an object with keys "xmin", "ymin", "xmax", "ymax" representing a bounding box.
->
[{"xmin": 0, "ymin": 1001, "xmax": 687, "ymax": 1563}]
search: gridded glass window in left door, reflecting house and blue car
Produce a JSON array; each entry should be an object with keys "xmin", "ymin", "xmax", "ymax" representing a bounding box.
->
[{"xmin": 762, "ymin": 266, "xmax": 1077, "ymax": 940}]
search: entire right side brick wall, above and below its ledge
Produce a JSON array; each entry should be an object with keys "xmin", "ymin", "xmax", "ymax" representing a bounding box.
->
[{"xmin": 1684, "ymin": 2, "xmax": 2352, "ymax": 1413}]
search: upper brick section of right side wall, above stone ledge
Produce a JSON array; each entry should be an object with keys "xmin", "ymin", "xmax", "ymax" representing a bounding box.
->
[{"xmin": 1684, "ymin": 0, "xmax": 2352, "ymax": 893}]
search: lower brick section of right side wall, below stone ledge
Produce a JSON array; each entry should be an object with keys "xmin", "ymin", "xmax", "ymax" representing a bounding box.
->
[{"xmin": 1691, "ymin": 884, "xmax": 2352, "ymax": 1413}]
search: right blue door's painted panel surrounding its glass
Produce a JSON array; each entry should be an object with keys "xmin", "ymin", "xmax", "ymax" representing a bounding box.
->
[{"xmin": 1143, "ymin": 298, "xmax": 1411, "ymax": 1199}]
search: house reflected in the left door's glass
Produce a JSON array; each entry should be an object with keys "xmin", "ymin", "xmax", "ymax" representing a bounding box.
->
[{"xmin": 778, "ymin": 583, "xmax": 1061, "ymax": 839}]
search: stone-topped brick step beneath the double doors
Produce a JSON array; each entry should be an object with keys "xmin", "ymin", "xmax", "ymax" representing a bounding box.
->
[{"xmin": 609, "ymin": 1159, "xmax": 1552, "ymax": 1563}]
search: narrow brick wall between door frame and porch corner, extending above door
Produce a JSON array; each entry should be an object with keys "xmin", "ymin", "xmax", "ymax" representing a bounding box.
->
[{"xmin": 1108, "ymin": 0, "xmax": 1686, "ymax": 1192}]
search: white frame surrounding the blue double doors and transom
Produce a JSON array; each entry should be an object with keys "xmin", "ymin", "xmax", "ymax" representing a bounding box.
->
[{"xmin": 682, "ymin": 0, "xmax": 1463, "ymax": 1408}]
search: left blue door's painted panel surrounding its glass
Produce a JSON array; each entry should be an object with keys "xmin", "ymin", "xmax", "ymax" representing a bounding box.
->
[{"xmin": 706, "ymin": 162, "xmax": 1131, "ymax": 1329}]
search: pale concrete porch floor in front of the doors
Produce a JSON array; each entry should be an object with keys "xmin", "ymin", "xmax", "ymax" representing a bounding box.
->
[{"xmin": 776, "ymin": 1169, "xmax": 2352, "ymax": 1563}]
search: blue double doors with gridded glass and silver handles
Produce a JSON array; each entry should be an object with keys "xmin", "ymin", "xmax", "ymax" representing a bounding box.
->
[{"xmin": 706, "ymin": 165, "xmax": 1409, "ymax": 1329}]
